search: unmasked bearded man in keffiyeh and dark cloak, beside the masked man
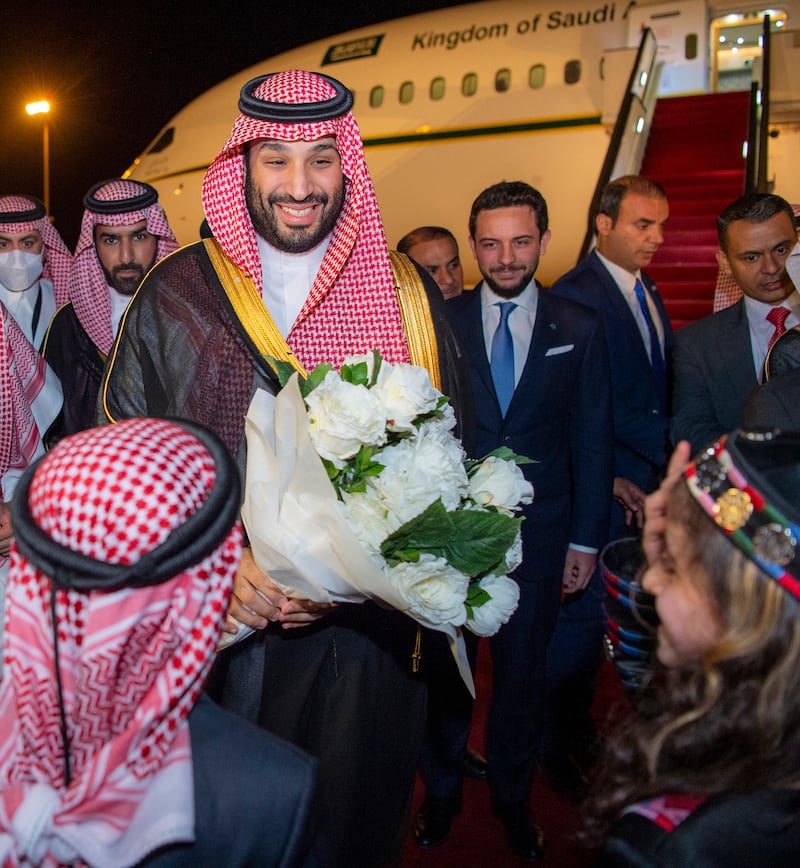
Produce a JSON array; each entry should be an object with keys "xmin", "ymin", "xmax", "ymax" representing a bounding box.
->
[{"xmin": 42, "ymin": 178, "xmax": 178, "ymax": 446}]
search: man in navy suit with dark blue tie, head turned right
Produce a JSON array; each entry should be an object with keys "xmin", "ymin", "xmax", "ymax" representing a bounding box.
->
[{"xmin": 540, "ymin": 175, "xmax": 672, "ymax": 790}]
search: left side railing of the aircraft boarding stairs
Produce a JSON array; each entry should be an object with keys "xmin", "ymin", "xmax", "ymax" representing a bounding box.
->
[{"xmin": 578, "ymin": 27, "xmax": 661, "ymax": 262}]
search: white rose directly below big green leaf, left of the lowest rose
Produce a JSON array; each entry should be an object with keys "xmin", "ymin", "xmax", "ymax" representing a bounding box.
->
[{"xmin": 388, "ymin": 554, "xmax": 469, "ymax": 627}]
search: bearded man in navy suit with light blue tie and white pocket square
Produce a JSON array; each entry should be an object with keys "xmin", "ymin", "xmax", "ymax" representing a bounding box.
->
[{"xmin": 432, "ymin": 182, "xmax": 612, "ymax": 858}]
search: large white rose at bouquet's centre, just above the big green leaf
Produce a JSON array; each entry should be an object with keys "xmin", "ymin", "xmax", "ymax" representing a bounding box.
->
[{"xmin": 369, "ymin": 423, "xmax": 468, "ymax": 526}]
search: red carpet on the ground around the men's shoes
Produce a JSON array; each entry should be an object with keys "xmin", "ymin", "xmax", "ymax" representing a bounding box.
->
[{"xmin": 402, "ymin": 640, "xmax": 628, "ymax": 868}]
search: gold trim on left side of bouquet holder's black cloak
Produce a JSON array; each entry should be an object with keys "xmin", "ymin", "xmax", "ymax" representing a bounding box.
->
[{"xmin": 203, "ymin": 238, "xmax": 308, "ymax": 377}]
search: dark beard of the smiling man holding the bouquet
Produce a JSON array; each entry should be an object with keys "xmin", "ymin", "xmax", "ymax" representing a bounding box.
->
[{"xmin": 245, "ymin": 172, "xmax": 344, "ymax": 253}]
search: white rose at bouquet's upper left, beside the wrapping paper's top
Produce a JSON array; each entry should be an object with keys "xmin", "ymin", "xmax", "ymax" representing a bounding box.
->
[{"xmin": 306, "ymin": 371, "xmax": 386, "ymax": 468}]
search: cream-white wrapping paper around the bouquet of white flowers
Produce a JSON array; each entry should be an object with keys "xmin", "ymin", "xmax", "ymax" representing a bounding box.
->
[{"xmin": 220, "ymin": 375, "xmax": 475, "ymax": 696}]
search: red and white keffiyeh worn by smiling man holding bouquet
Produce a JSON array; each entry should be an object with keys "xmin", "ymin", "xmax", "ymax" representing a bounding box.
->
[{"xmin": 203, "ymin": 69, "xmax": 410, "ymax": 369}]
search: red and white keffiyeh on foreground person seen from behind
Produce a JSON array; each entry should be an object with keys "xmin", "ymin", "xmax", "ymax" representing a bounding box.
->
[{"xmin": 0, "ymin": 419, "xmax": 242, "ymax": 868}]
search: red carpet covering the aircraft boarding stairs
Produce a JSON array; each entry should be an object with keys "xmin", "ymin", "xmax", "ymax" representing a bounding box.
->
[{"xmin": 641, "ymin": 91, "xmax": 750, "ymax": 328}]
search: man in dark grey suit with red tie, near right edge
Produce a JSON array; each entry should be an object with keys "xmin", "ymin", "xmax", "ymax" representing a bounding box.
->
[{"xmin": 671, "ymin": 193, "xmax": 800, "ymax": 451}]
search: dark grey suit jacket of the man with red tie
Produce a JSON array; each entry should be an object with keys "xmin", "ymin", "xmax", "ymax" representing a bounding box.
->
[{"xmin": 672, "ymin": 298, "xmax": 758, "ymax": 452}]
